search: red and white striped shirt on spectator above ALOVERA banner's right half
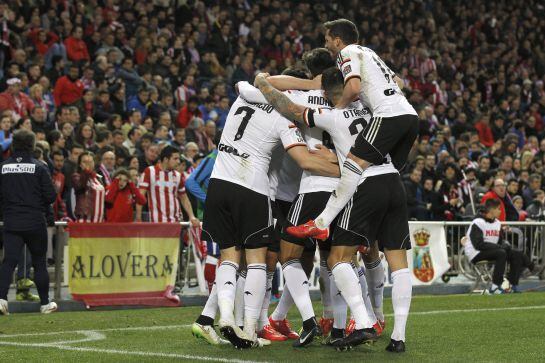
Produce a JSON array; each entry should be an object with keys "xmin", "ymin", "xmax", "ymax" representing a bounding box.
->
[{"xmin": 138, "ymin": 164, "xmax": 185, "ymax": 223}]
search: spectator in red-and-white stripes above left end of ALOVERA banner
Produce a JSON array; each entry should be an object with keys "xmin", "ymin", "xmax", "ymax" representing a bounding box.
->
[{"xmin": 72, "ymin": 151, "xmax": 105, "ymax": 223}]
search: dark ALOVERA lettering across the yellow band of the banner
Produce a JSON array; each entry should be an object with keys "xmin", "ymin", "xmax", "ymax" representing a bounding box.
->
[{"xmin": 72, "ymin": 252, "xmax": 174, "ymax": 279}]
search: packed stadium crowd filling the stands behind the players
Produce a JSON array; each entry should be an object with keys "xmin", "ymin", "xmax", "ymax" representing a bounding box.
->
[{"xmin": 0, "ymin": 0, "xmax": 545, "ymax": 226}]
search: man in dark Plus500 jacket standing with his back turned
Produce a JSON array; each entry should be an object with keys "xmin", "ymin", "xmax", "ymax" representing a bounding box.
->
[{"xmin": 0, "ymin": 130, "xmax": 57, "ymax": 315}]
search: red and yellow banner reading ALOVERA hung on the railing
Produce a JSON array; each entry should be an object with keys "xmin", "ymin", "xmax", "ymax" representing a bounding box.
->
[{"xmin": 68, "ymin": 223, "xmax": 181, "ymax": 306}]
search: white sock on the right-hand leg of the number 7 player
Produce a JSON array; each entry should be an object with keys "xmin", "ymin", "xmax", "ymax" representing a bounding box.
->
[{"xmin": 244, "ymin": 263, "xmax": 267, "ymax": 337}]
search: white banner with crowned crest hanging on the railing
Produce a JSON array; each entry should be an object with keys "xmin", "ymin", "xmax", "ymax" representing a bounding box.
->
[{"xmin": 407, "ymin": 222, "xmax": 450, "ymax": 285}]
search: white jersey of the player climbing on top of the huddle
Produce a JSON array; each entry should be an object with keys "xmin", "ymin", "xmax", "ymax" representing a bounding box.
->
[{"xmin": 337, "ymin": 44, "xmax": 417, "ymax": 117}]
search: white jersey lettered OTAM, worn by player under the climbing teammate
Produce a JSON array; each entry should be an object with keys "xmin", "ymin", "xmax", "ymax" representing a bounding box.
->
[{"xmin": 303, "ymin": 103, "xmax": 398, "ymax": 184}]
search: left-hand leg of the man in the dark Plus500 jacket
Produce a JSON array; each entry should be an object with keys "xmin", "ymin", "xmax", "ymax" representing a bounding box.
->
[{"xmin": 0, "ymin": 230, "xmax": 24, "ymax": 315}]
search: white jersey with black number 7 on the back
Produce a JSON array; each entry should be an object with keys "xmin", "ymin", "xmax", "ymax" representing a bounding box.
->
[{"xmin": 211, "ymin": 97, "xmax": 306, "ymax": 196}]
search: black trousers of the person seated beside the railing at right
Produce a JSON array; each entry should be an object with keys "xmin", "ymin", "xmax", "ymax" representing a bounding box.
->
[{"xmin": 471, "ymin": 247, "xmax": 525, "ymax": 286}]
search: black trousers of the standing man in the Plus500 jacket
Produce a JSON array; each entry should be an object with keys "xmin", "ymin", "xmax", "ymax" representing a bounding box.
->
[{"xmin": 0, "ymin": 229, "xmax": 49, "ymax": 305}]
